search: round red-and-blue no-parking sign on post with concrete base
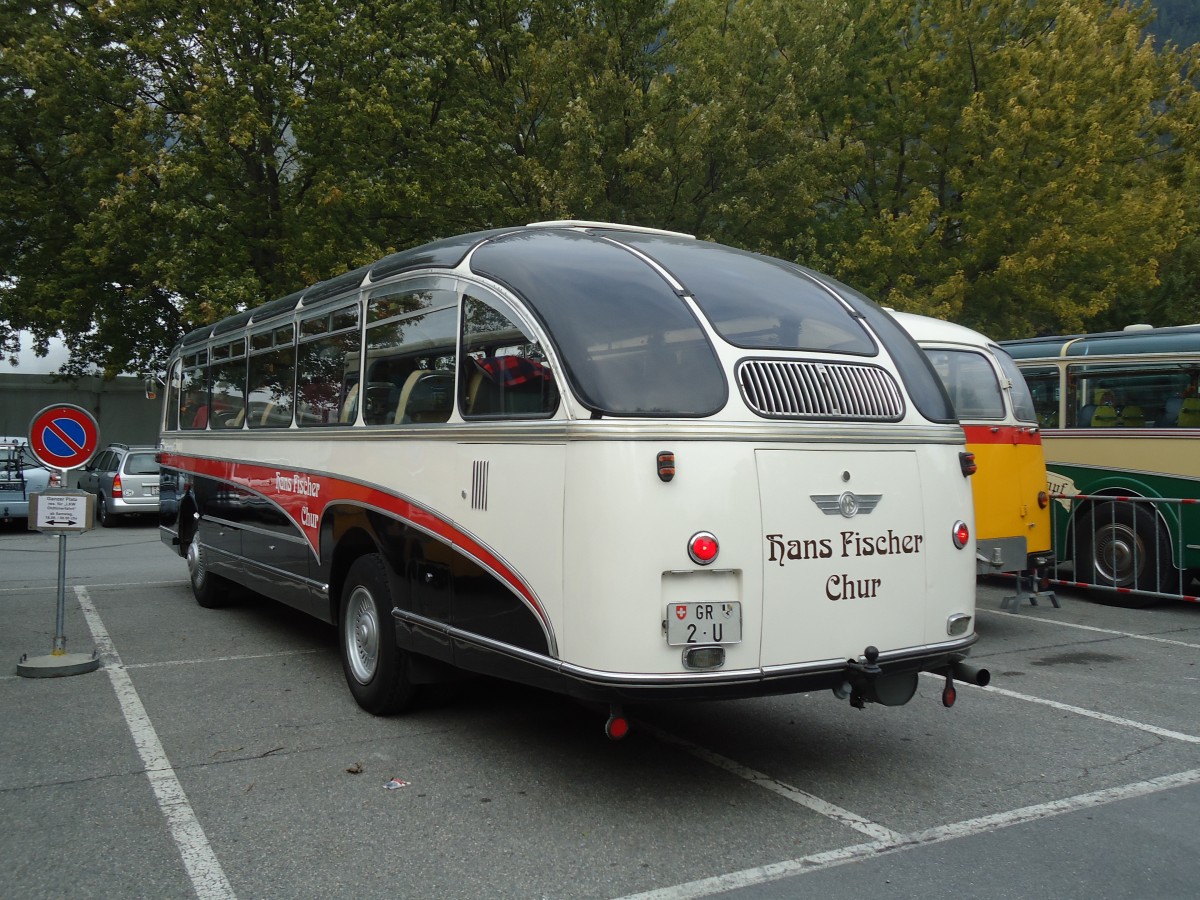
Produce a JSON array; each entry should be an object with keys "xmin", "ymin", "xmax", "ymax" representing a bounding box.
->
[{"xmin": 17, "ymin": 403, "xmax": 100, "ymax": 678}]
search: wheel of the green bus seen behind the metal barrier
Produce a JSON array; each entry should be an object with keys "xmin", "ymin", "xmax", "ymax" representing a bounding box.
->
[{"xmin": 1075, "ymin": 503, "xmax": 1180, "ymax": 607}]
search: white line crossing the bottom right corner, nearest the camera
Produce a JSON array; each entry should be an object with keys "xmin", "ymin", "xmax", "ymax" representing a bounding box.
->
[{"xmin": 620, "ymin": 769, "xmax": 1200, "ymax": 900}]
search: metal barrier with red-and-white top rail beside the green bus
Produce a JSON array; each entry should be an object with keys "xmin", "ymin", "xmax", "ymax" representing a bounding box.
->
[{"xmin": 1040, "ymin": 493, "xmax": 1200, "ymax": 606}]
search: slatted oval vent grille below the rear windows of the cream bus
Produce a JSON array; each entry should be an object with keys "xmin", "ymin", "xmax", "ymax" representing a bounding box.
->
[{"xmin": 737, "ymin": 359, "xmax": 904, "ymax": 421}]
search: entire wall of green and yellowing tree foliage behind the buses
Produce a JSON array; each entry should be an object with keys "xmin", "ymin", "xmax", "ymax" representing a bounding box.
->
[{"xmin": 0, "ymin": 0, "xmax": 1200, "ymax": 374}]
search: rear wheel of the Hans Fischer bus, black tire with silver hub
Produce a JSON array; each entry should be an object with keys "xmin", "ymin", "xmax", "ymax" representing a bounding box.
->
[{"xmin": 337, "ymin": 553, "xmax": 414, "ymax": 715}]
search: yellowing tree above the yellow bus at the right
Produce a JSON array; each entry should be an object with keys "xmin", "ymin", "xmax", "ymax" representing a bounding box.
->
[{"xmin": 796, "ymin": 0, "xmax": 1194, "ymax": 337}]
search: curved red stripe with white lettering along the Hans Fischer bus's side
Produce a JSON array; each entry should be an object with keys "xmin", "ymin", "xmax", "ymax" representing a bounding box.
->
[{"xmin": 161, "ymin": 452, "xmax": 550, "ymax": 630}]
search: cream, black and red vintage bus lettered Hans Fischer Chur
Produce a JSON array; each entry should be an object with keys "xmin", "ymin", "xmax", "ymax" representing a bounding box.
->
[{"xmin": 154, "ymin": 222, "xmax": 986, "ymax": 737}]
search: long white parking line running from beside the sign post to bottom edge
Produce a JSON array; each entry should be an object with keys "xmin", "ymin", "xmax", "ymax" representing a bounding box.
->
[{"xmin": 74, "ymin": 586, "xmax": 236, "ymax": 900}]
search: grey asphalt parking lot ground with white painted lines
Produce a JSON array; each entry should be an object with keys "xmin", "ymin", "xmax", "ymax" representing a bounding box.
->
[{"xmin": 0, "ymin": 522, "xmax": 1200, "ymax": 900}]
